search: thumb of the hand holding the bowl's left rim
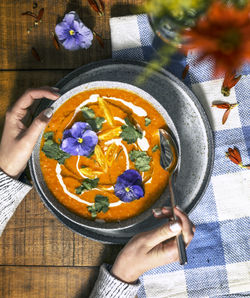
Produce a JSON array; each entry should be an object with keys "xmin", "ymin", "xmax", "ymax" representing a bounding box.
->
[{"xmin": 25, "ymin": 108, "xmax": 53, "ymax": 146}]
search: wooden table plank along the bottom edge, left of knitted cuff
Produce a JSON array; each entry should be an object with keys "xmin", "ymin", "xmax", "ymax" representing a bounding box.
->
[{"xmin": 0, "ymin": 266, "xmax": 98, "ymax": 298}]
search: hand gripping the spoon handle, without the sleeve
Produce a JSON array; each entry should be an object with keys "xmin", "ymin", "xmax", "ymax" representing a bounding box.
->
[{"xmin": 111, "ymin": 207, "xmax": 195, "ymax": 283}]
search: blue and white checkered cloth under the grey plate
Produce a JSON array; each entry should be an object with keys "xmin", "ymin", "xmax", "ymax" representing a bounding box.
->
[{"xmin": 110, "ymin": 15, "xmax": 250, "ymax": 298}]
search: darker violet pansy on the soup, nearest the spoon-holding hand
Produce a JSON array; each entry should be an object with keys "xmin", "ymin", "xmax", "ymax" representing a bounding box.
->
[{"xmin": 115, "ymin": 170, "xmax": 144, "ymax": 202}]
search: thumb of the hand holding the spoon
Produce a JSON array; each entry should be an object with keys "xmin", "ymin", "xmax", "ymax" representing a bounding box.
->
[{"xmin": 147, "ymin": 221, "xmax": 182, "ymax": 248}]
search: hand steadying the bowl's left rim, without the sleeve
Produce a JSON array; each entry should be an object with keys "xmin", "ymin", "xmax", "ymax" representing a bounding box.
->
[{"xmin": 0, "ymin": 86, "xmax": 60, "ymax": 178}]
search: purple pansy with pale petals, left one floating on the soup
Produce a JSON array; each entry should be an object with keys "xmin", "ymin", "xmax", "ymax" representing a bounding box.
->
[{"xmin": 60, "ymin": 122, "xmax": 98, "ymax": 156}]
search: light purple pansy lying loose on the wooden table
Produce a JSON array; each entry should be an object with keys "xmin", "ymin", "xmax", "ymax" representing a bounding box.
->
[{"xmin": 55, "ymin": 11, "xmax": 93, "ymax": 51}]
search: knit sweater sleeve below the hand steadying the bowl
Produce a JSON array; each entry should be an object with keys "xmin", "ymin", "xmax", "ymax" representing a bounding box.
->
[{"xmin": 0, "ymin": 171, "xmax": 31, "ymax": 236}]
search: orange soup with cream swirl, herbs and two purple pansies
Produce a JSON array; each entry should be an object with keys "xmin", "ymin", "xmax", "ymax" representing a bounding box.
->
[{"xmin": 40, "ymin": 88, "xmax": 168, "ymax": 222}]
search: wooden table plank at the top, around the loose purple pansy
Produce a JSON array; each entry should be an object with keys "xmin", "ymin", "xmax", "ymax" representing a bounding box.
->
[{"xmin": 0, "ymin": 0, "xmax": 143, "ymax": 70}]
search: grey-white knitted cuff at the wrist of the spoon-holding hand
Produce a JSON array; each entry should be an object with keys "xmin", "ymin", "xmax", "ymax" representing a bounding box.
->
[{"xmin": 90, "ymin": 264, "xmax": 140, "ymax": 298}]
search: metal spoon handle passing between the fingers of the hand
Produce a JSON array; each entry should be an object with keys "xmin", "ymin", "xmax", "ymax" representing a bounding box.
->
[{"xmin": 169, "ymin": 175, "xmax": 187, "ymax": 265}]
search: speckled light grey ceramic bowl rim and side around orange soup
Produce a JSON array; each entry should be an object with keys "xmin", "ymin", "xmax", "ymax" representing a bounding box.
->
[{"xmin": 30, "ymin": 81, "xmax": 181, "ymax": 230}]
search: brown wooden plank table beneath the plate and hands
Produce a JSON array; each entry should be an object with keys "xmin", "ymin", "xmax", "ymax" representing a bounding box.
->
[{"xmin": 0, "ymin": 0, "xmax": 143, "ymax": 298}]
